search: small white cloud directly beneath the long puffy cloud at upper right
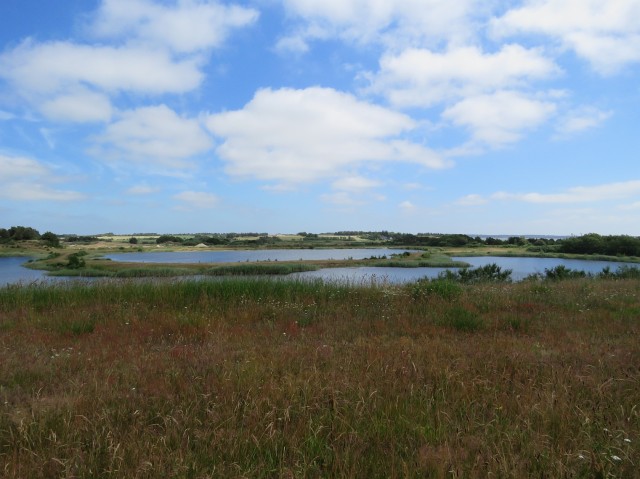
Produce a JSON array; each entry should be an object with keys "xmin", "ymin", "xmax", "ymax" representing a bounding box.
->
[{"xmin": 442, "ymin": 91, "xmax": 555, "ymax": 147}]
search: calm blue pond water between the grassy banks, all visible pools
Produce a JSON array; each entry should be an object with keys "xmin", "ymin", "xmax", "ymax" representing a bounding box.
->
[{"xmin": 0, "ymin": 253, "xmax": 640, "ymax": 287}]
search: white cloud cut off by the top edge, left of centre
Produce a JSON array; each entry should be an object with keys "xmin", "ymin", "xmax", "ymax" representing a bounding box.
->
[{"xmin": 90, "ymin": 0, "xmax": 259, "ymax": 53}]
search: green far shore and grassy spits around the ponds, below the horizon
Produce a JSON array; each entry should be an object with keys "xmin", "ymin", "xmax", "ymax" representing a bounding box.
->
[{"xmin": 0, "ymin": 226, "xmax": 640, "ymax": 277}]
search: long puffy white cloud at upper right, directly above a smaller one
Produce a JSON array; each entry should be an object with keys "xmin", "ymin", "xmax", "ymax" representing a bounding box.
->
[{"xmin": 370, "ymin": 45, "xmax": 558, "ymax": 107}]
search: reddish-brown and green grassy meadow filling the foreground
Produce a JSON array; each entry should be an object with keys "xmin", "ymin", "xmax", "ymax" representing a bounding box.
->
[{"xmin": 0, "ymin": 274, "xmax": 640, "ymax": 478}]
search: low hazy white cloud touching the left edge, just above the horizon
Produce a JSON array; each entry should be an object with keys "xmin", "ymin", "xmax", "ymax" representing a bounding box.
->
[{"xmin": 0, "ymin": 154, "xmax": 84, "ymax": 201}]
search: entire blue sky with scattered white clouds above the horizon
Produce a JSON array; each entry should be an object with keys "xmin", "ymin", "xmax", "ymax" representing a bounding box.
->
[{"xmin": 0, "ymin": 0, "xmax": 640, "ymax": 235}]
